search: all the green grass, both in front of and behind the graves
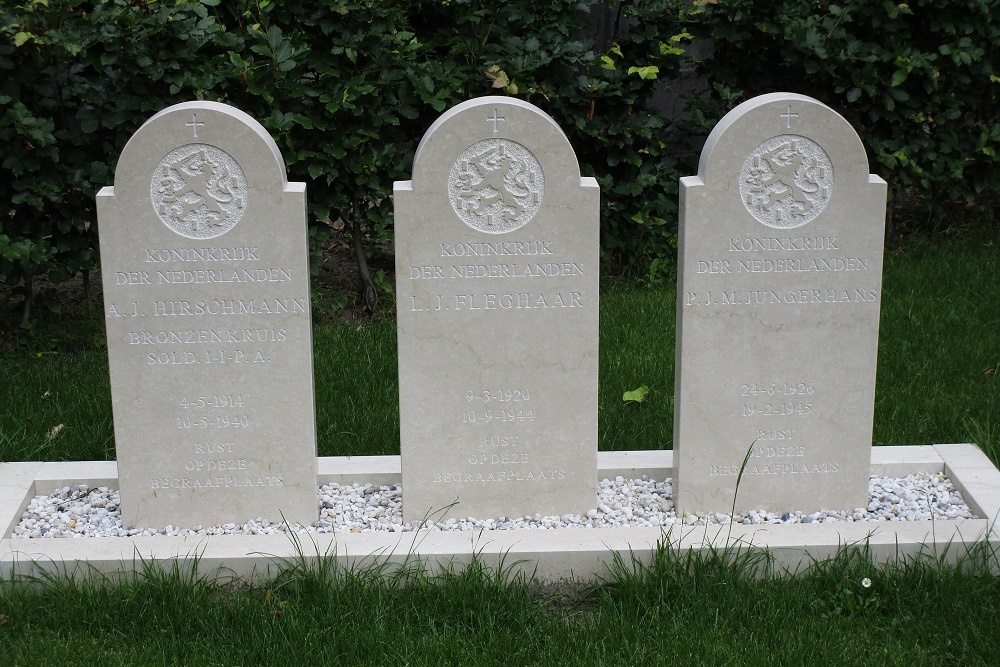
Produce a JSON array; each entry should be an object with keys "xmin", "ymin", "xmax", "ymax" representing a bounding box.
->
[{"xmin": 0, "ymin": 229, "xmax": 1000, "ymax": 666}]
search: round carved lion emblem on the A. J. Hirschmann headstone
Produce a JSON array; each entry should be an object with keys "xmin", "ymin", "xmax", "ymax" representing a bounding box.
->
[{"xmin": 149, "ymin": 144, "xmax": 247, "ymax": 239}]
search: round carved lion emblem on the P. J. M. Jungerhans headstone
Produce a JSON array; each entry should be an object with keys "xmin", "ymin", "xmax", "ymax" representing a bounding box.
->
[{"xmin": 740, "ymin": 134, "xmax": 833, "ymax": 229}]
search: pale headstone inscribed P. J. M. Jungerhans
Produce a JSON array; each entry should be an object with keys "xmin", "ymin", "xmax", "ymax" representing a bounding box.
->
[{"xmin": 674, "ymin": 93, "xmax": 886, "ymax": 514}]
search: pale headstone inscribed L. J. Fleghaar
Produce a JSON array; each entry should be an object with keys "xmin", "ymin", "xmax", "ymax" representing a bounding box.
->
[{"xmin": 395, "ymin": 97, "xmax": 600, "ymax": 521}]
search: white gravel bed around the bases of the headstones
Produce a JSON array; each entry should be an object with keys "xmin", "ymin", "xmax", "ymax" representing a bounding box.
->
[{"xmin": 11, "ymin": 473, "xmax": 973, "ymax": 539}]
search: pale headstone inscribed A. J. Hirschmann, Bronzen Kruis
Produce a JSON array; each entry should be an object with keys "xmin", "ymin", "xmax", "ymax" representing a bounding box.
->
[{"xmin": 97, "ymin": 102, "xmax": 319, "ymax": 528}]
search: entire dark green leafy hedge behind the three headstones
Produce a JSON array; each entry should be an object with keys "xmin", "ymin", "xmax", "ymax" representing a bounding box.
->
[{"xmin": 0, "ymin": 0, "xmax": 1000, "ymax": 324}]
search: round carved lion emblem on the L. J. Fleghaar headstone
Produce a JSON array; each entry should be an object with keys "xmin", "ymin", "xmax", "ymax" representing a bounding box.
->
[{"xmin": 448, "ymin": 138, "xmax": 545, "ymax": 234}]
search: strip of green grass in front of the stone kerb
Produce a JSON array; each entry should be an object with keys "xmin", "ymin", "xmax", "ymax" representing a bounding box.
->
[{"xmin": 0, "ymin": 551, "xmax": 1000, "ymax": 667}]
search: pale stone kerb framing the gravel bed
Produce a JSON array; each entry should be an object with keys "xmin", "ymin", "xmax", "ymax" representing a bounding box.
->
[{"xmin": 0, "ymin": 444, "xmax": 1000, "ymax": 581}]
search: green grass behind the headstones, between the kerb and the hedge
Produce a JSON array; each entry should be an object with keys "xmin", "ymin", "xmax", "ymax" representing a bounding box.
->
[{"xmin": 0, "ymin": 228, "xmax": 1000, "ymax": 461}]
